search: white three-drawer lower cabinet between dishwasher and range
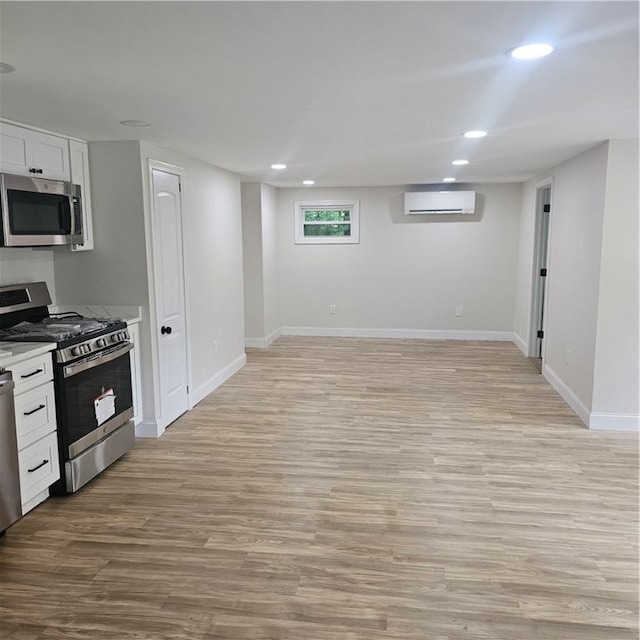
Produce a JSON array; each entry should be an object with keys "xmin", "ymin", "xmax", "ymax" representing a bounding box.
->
[{"xmin": 12, "ymin": 353, "xmax": 60, "ymax": 515}]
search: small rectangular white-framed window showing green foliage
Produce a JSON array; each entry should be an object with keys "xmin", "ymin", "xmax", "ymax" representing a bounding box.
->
[{"xmin": 295, "ymin": 200, "xmax": 360, "ymax": 244}]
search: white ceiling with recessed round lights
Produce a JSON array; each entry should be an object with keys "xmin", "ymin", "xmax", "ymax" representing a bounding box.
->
[{"xmin": 0, "ymin": 1, "xmax": 638, "ymax": 186}]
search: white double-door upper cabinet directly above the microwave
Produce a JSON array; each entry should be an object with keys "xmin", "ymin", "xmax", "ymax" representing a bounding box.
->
[{"xmin": 0, "ymin": 122, "xmax": 71, "ymax": 181}]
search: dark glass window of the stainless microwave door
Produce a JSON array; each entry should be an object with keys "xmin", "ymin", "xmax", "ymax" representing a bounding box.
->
[{"xmin": 7, "ymin": 189, "xmax": 71, "ymax": 235}]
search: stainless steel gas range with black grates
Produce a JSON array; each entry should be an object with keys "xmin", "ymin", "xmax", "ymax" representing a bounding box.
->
[{"xmin": 0, "ymin": 282, "xmax": 135, "ymax": 495}]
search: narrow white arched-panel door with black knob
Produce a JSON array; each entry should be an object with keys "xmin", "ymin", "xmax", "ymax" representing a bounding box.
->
[{"xmin": 151, "ymin": 166, "xmax": 189, "ymax": 429}]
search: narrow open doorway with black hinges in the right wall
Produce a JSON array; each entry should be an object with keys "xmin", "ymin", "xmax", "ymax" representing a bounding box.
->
[{"xmin": 529, "ymin": 183, "xmax": 551, "ymax": 373}]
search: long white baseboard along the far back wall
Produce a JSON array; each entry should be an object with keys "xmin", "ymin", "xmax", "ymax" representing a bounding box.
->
[{"xmin": 281, "ymin": 327, "xmax": 513, "ymax": 342}]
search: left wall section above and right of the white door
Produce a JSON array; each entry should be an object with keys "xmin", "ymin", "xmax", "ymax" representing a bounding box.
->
[{"xmin": 142, "ymin": 144, "xmax": 244, "ymax": 401}]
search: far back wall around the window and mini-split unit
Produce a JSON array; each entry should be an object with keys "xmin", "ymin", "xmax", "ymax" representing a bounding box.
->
[{"xmin": 278, "ymin": 184, "xmax": 521, "ymax": 337}]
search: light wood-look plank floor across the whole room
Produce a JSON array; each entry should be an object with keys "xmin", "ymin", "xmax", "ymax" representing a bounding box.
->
[{"xmin": 0, "ymin": 338, "xmax": 638, "ymax": 640}]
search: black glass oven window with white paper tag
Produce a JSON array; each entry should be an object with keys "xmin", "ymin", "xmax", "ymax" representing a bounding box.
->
[{"xmin": 58, "ymin": 351, "xmax": 133, "ymax": 446}]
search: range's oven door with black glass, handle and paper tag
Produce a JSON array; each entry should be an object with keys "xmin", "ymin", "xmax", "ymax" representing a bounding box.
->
[{"xmin": 56, "ymin": 342, "xmax": 133, "ymax": 460}]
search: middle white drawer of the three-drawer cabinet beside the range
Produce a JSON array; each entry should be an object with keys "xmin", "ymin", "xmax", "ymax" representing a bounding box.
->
[{"xmin": 15, "ymin": 382, "xmax": 56, "ymax": 450}]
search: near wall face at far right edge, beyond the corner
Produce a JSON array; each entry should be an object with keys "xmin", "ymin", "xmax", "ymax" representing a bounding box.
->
[{"xmin": 590, "ymin": 140, "xmax": 640, "ymax": 429}]
